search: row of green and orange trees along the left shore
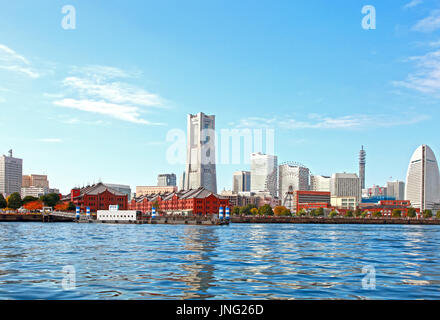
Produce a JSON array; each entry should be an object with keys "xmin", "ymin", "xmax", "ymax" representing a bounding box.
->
[{"xmin": 0, "ymin": 192, "xmax": 75, "ymax": 211}]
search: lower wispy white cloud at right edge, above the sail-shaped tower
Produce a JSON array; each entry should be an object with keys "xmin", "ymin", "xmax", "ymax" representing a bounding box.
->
[{"xmin": 393, "ymin": 50, "xmax": 440, "ymax": 97}]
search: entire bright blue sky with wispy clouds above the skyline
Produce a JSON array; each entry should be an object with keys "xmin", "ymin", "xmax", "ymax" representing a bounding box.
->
[{"xmin": 0, "ymin": 0, "xmax": 440, "ymax": 193}]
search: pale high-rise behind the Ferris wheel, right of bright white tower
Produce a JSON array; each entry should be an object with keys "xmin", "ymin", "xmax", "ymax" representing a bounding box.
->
[{"xmin": 278, "ymin": 163, "xmax": 310, "ymax": 199}]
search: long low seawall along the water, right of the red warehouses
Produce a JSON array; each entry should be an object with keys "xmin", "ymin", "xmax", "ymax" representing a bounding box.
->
[{"xmin": 231, "ymin": 216, "xmax": 440, "ymax": 225}]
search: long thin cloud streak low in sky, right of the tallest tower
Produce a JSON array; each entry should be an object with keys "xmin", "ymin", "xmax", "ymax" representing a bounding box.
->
[{"xmin": 231, "ymin": 114, "xmax": 429, "ymax": 130}]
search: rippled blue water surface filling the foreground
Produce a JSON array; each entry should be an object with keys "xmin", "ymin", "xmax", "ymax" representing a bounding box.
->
[{"xmin": 0, "ymin": 223, "xmax": 440, "ymax": 299}]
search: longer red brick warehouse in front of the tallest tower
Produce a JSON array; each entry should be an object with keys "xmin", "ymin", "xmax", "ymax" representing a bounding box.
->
[{"xmin": 128, "ymin": 187, "xmax": 230, "ymax": 215}]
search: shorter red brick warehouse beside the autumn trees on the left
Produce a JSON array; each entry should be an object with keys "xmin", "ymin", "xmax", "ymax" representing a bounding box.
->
[{"xmin": 62, "ymin": 182, "xmax": 128, "ymax": 212}]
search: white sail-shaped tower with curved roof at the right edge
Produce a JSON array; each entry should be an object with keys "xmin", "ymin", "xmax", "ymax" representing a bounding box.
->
[{"xmin": 405, "ymin": 145, "xmax": 440, "ymax": 210}]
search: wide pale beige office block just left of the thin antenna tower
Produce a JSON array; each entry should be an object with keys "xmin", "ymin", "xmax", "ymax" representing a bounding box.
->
[{"xmin": 330, "ymin": 173, "xmax": 362, "ymax": 203}]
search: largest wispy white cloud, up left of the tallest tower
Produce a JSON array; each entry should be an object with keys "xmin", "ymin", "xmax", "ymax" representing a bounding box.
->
[{"xmin": 53, "ymin": 66, "xmax": 166, "ymax": 125}]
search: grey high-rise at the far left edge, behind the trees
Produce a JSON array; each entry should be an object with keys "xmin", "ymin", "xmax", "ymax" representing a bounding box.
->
[{"xmin": 0, "ymin": 150, "xmax": 23, "ymax": 196}]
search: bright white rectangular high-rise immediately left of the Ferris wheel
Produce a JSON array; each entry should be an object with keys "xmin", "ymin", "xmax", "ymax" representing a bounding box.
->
[{"xmin": 251, "ymin": 152, "xmax": 278, "ymax": 197}]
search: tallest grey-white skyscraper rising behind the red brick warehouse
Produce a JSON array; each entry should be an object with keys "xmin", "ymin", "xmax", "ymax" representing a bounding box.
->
[{"xmin": 184, "ymin": 112, "xmax": 217, "ymax": 193}]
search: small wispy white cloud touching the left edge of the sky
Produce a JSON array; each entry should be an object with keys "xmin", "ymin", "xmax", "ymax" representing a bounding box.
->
[{"xmin": 0, "ymin": 44, "xmax": 40, "ymax": 79}]
